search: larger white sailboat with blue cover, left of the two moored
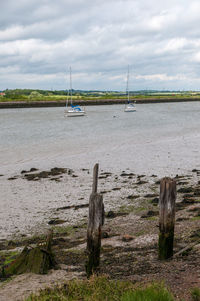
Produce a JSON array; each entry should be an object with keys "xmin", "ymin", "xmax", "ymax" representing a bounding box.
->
[{"xmin": 65, "ymin": 66, "xmax": 85, "ymax": 117}]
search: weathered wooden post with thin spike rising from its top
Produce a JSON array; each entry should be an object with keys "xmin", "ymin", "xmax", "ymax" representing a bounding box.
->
[{"xmin": 86, "ymin": 164, "xmax": 104, "ymax": 277}]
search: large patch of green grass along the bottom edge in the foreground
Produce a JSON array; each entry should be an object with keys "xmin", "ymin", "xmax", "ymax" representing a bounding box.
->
[{"xmin": 26, "ymin": 276, "xmax": 175, "ymax": 301}]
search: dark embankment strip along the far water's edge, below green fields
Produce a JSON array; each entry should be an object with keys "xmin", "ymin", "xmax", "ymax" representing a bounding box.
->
[{"xmin": 0, "ymin": 98, "xmax": 200, "ymax": 109}]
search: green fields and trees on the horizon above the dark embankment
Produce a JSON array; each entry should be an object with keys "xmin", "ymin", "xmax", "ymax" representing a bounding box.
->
[{"xmin": 0, "ymin": 89, "xmax": 200, "ymax": 102}]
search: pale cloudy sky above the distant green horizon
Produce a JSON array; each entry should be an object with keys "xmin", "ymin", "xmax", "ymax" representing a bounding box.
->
[{"xmin": 0, "ymin": 0, "xmax": 200, "ymax": 91}]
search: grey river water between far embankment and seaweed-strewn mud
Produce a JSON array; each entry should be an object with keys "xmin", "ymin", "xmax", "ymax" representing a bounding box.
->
[{"xmin": 0, "ymin": 102, "xmax": 200, "ymax": 175}]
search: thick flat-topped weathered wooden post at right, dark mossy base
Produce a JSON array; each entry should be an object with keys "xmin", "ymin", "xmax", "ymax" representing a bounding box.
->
[{"xmin": 158, "ymin": 178, "xmax": 176, "ymax": 260}]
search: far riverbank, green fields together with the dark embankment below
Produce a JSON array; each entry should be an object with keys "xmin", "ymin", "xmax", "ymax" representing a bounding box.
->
[{"xmin": 0, "ymin": 89, "xmax": 200, "ymax": 108}]
